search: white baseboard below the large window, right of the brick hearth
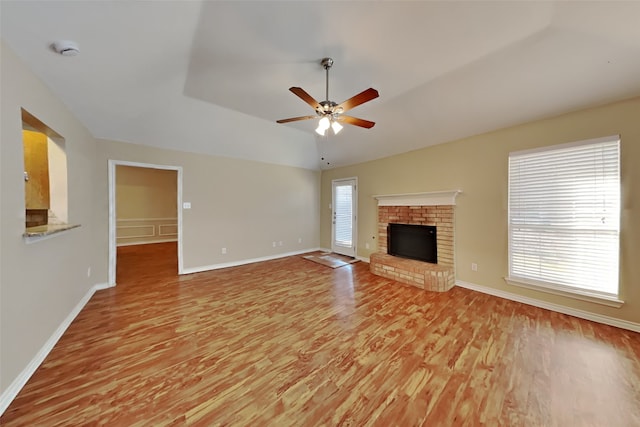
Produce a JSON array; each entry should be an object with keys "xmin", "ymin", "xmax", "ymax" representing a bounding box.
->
[{"xmin": 456, "ymin": 280, "xmax": 640, "ymax": 332}]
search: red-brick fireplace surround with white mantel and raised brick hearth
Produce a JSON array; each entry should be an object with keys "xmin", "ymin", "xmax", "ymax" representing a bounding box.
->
[{"xmin": 369, "ymin": 190, "xmax": 460, "ymax": 292}]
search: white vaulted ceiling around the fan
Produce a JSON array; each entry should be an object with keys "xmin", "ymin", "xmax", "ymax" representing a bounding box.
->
[{"xmin": 0, "ymin": 0, "xmax": 640, "ymax": 169}]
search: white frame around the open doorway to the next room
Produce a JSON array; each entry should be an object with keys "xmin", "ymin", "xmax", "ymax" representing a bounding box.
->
[{"xmin": 108, "ymin": 159, "xmax": 184, "ymax": 286}]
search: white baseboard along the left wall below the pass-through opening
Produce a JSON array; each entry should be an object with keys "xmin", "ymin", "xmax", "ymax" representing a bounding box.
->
[{"xmin": 0, "ymin": 283, "xmax": 110, "ymax": 415}]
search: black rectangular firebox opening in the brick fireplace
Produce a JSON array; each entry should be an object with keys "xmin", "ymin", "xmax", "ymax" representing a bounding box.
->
[{"xmin": 387, "ymin": 223, "xmax": 438, "ymax": 264}]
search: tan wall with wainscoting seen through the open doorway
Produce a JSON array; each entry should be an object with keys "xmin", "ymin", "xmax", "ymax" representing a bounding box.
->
[{"xmin": 116, "ymin": 165, "xmax": 178, "ymax": 245}]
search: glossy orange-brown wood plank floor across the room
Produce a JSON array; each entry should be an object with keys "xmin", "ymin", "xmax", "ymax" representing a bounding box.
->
[{"xmin": 0, "ymin": 244, "xmax": 640, "ymax": 427}]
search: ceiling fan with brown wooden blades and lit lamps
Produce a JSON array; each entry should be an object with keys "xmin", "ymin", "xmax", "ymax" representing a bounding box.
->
[{"xmin": 277, "ymin": 58, "xmax": 379, "ymax": 136}]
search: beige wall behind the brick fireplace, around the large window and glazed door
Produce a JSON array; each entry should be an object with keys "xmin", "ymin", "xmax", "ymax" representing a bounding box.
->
[{"xmin": 320, "ymin": 98, "xmax": 640, "ymax": 323}]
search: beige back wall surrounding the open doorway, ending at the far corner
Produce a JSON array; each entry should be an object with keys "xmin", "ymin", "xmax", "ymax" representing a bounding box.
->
[{"xmin": 96, "ymin": 140, "xmax": 320, "ymax": 272}]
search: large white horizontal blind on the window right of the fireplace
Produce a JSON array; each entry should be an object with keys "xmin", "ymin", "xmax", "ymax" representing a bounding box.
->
[{"xmin": 509, "ymin": 136, "xmax": 620, "ymax": 295}]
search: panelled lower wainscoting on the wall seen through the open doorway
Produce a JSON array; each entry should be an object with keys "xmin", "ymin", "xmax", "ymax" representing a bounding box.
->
[{"xmin": 116, "ymin": 218, "xmax": 178, "ymax": 246}]
